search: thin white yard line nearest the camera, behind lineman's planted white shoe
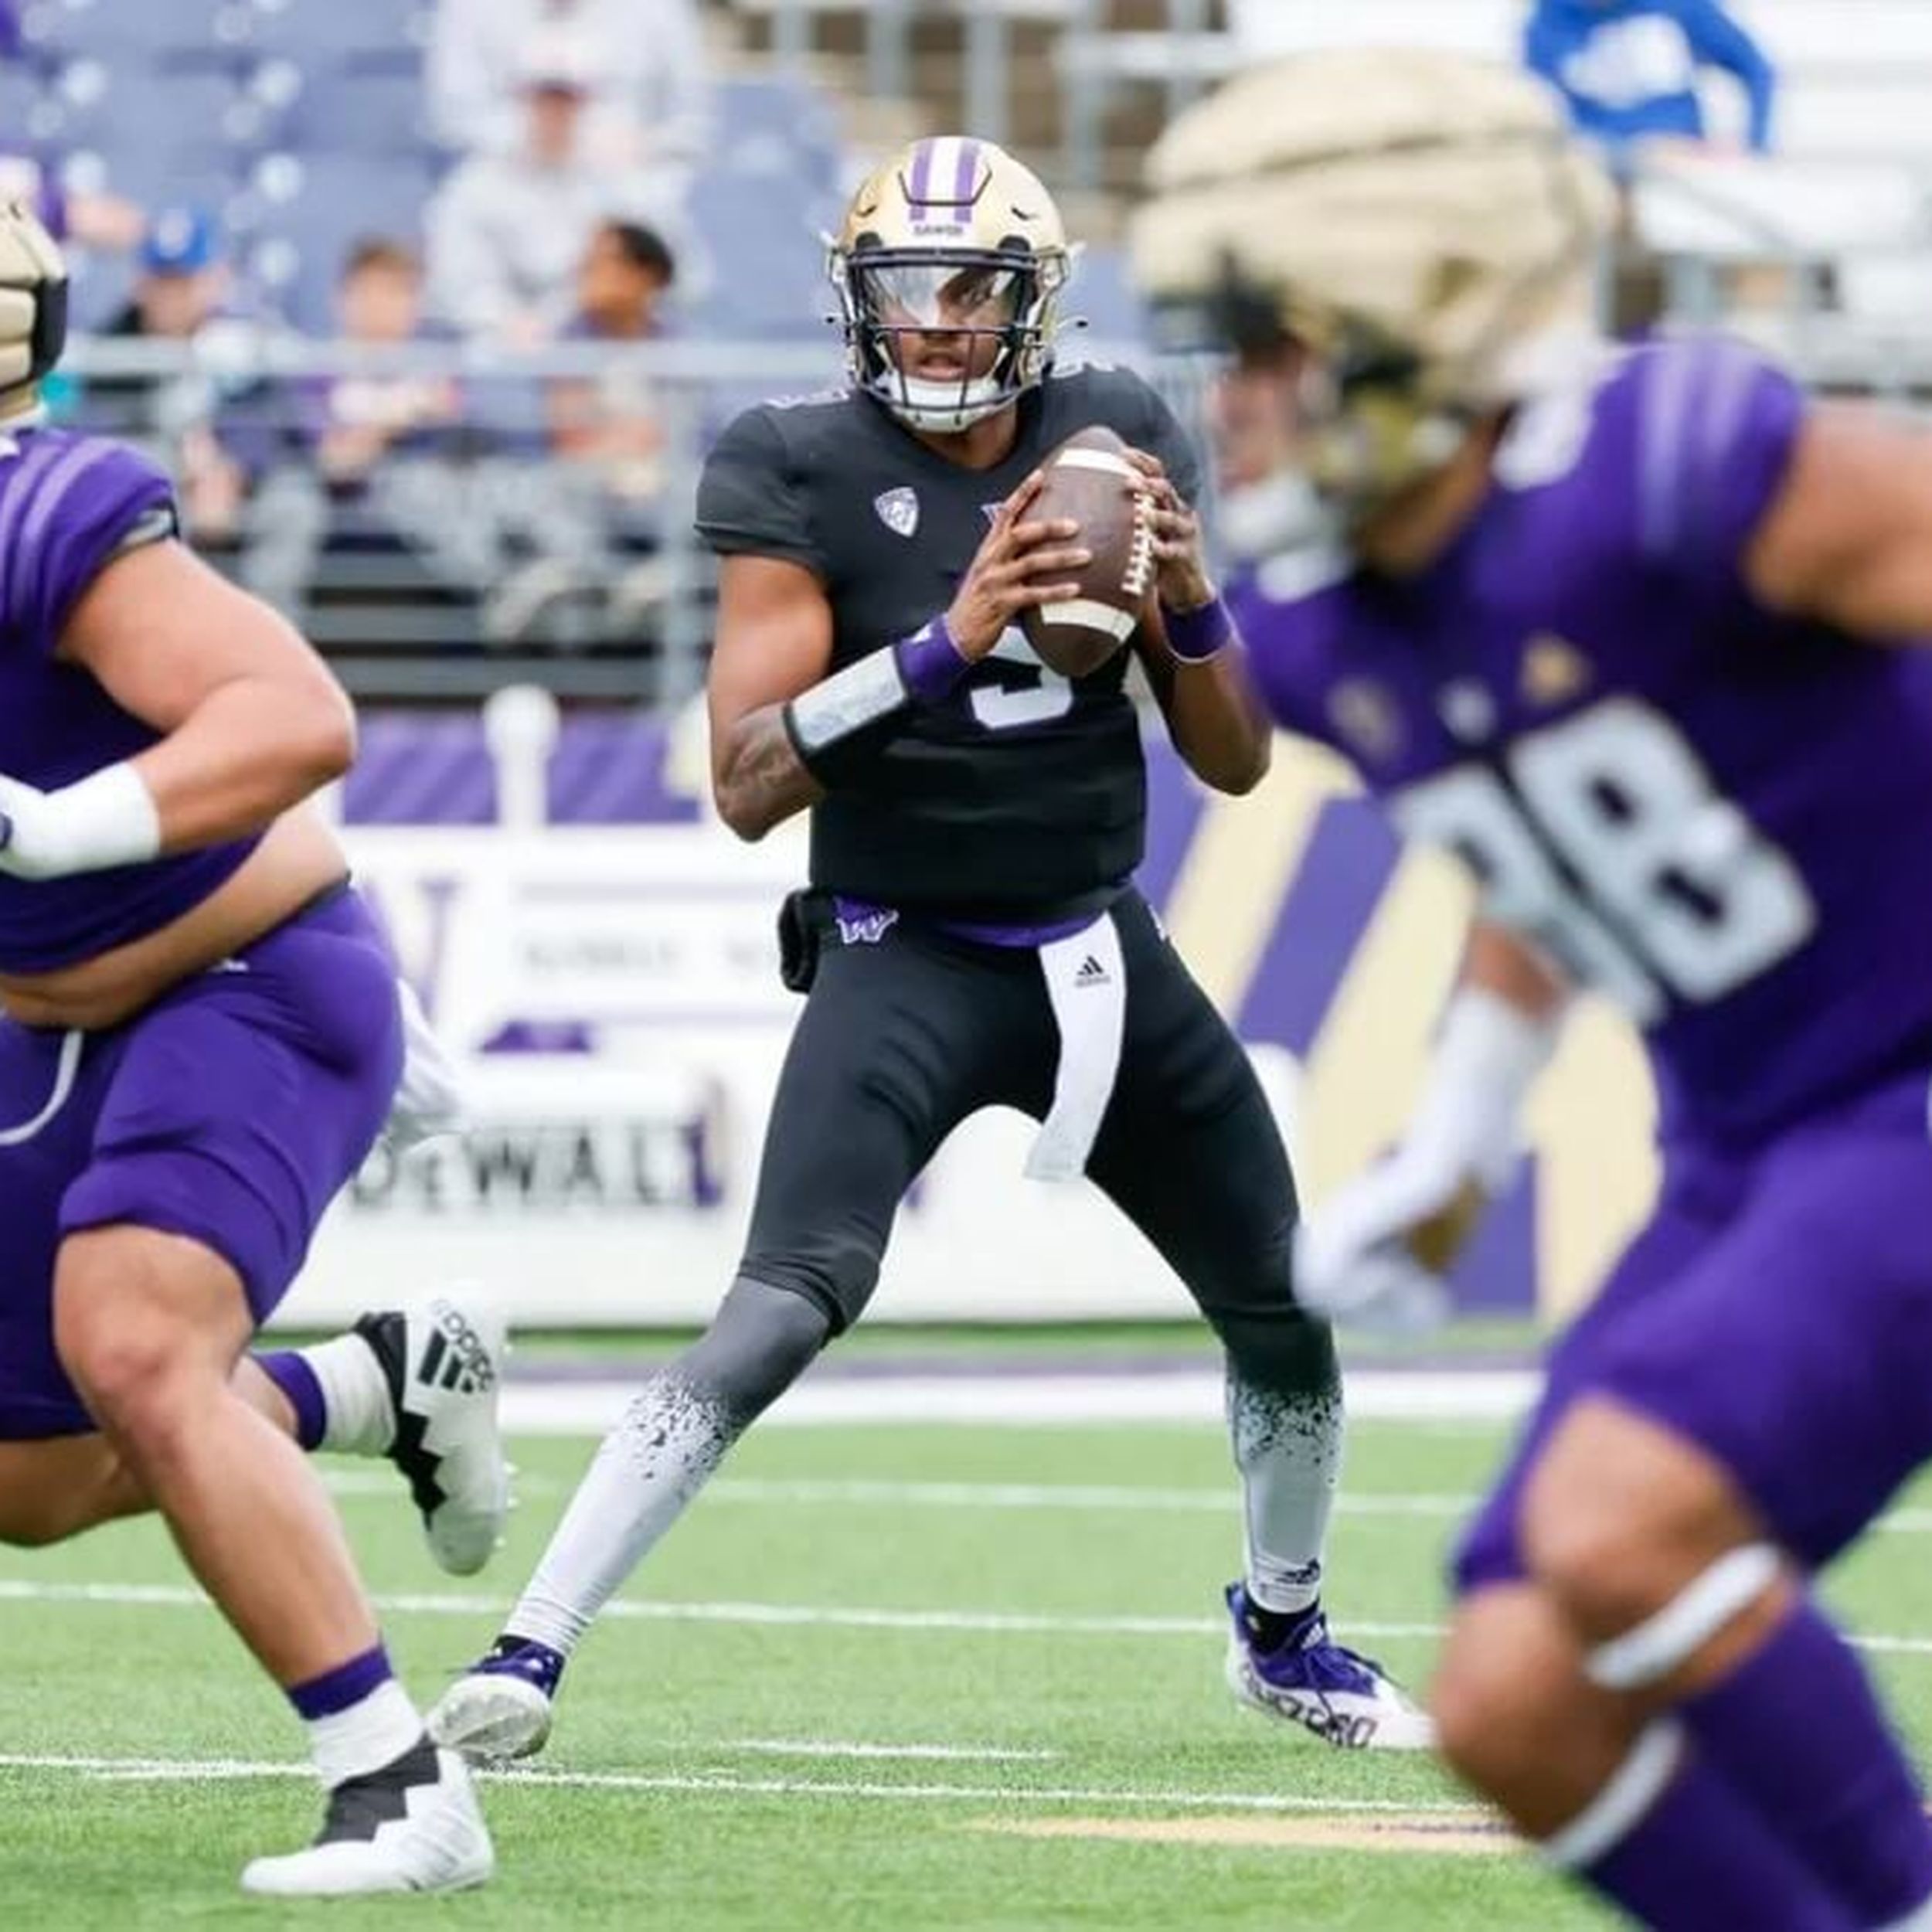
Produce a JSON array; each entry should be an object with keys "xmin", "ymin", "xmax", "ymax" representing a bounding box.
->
[{"xmin": 0, "ymin": 1753, "xmax": 1484, "ymax": 1824}]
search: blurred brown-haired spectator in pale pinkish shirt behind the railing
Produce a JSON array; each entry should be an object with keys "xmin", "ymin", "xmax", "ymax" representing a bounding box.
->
[{"xmin": 304, "ymin": 238, "xmax": 464, "ymax": 495}]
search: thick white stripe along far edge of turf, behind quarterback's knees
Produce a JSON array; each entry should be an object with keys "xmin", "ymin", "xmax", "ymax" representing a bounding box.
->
[{"xmin": 502, "ymin": 1368, "xmax": 1540, "ymax": 1436}]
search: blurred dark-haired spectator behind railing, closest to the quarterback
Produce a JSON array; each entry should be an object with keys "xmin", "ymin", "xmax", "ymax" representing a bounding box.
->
[{"xmin": 551, "ymin": 223, "xmax": 676, "ymax": 501}]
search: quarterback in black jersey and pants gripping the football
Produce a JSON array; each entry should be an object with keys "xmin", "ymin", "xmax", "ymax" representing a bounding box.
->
[{"xmin": 435, "ymin": 138, "xmax": 1430, "ymax": 1757}]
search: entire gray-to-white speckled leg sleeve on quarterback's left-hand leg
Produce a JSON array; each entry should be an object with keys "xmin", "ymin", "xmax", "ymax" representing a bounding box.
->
[{"xmin": 505, "ymin": 1279, "xmax": 831, "ymax": 1656}]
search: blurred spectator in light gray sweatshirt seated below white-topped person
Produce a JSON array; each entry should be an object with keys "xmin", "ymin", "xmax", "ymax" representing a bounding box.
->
[{"xmin": 429, "ymin": 29, "xmax": 684, "ymax": 346}]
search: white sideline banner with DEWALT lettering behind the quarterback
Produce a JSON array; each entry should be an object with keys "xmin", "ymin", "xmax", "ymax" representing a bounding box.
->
[{"xmin": 284, "ymin": 823, "xmax": 1294, "ymax": 1325}]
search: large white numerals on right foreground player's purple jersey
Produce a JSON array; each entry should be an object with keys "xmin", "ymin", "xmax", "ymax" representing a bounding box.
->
[{"xmin": 1393, "ymin": 698, "xmax": 1818, "ymax": 1026}]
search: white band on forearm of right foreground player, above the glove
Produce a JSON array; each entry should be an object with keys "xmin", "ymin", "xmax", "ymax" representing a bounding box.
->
[{"xmin": 1403, "ymin": 985, "xmax": 1560, "ymax": 1189}]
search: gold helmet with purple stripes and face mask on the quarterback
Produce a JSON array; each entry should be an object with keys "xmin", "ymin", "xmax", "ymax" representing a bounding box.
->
[{"xmin": 827, "ymin": 135, "xmax": 1073, "ymax": 431}]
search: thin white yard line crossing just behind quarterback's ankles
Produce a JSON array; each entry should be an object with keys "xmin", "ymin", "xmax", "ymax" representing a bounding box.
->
[{"xmin": 11, "ymin": 1577, "xmax": 1932, "ymax": 1654}]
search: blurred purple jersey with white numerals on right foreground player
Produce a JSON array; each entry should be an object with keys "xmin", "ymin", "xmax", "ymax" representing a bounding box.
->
[{"xmin": 1233, "ymin": 340, "xmax": 1932, "ymax": 1140}]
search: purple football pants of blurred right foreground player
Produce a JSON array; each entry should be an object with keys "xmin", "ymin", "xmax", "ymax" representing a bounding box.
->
[{"xmin": 1455, "ymin": 1074, "xmax": 1932, "ymax": 1592}]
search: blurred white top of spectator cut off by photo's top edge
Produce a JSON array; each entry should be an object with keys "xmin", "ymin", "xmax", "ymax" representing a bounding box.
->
[{"xmin": 429, "ymin": 0, "xmax": 709, "ymax": 180}]
